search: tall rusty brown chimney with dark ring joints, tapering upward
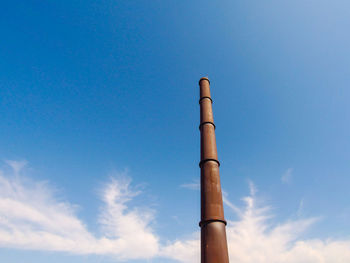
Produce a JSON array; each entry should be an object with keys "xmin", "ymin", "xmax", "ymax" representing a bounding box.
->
[{"xmin": 199, "ymin": 78, "xmax": 229, "ymax": 263}]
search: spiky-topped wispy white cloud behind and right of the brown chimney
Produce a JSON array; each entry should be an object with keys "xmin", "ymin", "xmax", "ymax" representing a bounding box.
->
[{"xmin": 168, "ymin": 183, "xmax": 350, "ymax": 263}]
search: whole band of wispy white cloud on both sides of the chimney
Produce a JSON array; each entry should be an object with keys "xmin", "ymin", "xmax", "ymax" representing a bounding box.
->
[{"xmin": 0, "ymin": 162, "xmax": 350, "ymax": 263}]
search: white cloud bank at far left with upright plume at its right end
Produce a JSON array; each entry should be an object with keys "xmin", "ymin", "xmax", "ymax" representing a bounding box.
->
[{"xmin": 0, "ymin": 162, "xmax": 158, "ymax": 260}]
